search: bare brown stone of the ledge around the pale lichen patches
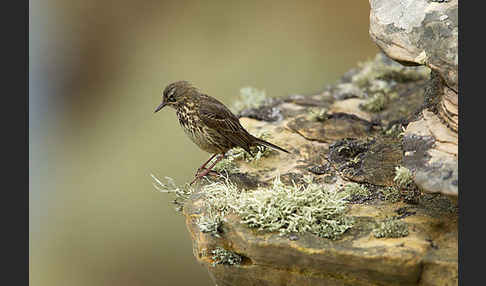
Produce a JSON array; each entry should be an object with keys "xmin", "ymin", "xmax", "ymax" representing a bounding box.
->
[{"xmin": 174, "ymin": 55, "xmax": 458, "ymax": 286}]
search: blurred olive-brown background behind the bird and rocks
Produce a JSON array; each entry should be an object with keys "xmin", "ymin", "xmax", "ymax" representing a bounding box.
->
[{"xmin": 29, "ymin": 0, "xmax": 378, "ymax": 286}]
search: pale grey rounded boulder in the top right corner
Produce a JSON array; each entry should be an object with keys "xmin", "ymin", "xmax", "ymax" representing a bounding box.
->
[{"xmin": 370, "ymin": 0, "xmax": 459, "ymax": 92}]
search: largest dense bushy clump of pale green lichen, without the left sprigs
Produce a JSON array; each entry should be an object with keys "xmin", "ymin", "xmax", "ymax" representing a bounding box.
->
[{"xmin": 223, "ymin": 176, "xmax": 352, "ymax": 239}]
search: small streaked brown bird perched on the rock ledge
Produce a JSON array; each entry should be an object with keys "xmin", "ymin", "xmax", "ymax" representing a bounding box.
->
[{"xmin": 155, "ymin": 81, "xmax": 290, "ymax": 184}]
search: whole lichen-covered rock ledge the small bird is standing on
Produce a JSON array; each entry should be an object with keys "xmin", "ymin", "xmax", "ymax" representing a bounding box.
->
[{"xmin": 164, "ymin": 54, "xmax": 458, "ymax": 285}]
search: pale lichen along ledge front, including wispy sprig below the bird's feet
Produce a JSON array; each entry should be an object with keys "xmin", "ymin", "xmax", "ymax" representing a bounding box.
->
[{"xmin": 154, "ymin": 172, "xmax": 353, "ymax": 239}]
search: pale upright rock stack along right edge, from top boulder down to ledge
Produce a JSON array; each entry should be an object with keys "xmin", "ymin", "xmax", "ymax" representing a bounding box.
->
[{"xmin": 370, "ymin": 0, "xmax": 459, "ymax": 196}]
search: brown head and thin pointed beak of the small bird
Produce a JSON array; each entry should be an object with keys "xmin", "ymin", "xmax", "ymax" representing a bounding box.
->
[{"xmin": 154, "ymin": 81, "xmax": 196, "ymax": 112}]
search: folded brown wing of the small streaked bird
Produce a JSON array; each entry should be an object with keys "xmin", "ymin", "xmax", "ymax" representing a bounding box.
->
[{"xmin": 199, "ymin": 102, "xmax": 252, "ymax": 154}]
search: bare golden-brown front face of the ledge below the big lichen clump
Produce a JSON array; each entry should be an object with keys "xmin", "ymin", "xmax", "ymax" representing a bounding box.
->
[{"xmin": 184, "ymin": 179, "xmax": 457, "ymax": 285}]
